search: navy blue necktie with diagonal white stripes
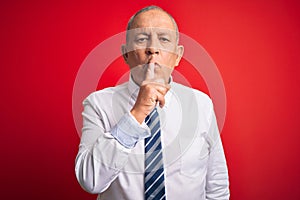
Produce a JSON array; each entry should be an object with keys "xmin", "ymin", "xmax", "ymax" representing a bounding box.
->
[{"xmin": 145, "ymin": 108, "xmax": 166, "ymax": 200}]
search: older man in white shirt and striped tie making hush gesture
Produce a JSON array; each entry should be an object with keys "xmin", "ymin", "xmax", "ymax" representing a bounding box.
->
[{"xmin": 75, "ymin": 6, "xmax": 229, "ymax": 200}]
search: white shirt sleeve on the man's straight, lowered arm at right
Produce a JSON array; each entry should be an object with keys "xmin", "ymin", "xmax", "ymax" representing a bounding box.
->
[{"xmin": 206, "ymin": 112, "xmax": 230, "ymax": 200}]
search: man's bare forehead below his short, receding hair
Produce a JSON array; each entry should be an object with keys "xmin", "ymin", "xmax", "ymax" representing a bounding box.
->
[{"xmin": 130, "ymin": 10, "xmax": 175, "ymax": 30}]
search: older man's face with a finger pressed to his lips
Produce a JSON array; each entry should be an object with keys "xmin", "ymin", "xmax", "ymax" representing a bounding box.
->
[{"xmin": 122, "ymin": 10, "xmax": 183, "ymax": 85}]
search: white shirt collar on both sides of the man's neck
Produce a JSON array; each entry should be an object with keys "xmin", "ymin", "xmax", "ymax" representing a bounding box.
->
[{"xmin": 128, "ymin": 73, "xmax": 173, "ymax": 108}]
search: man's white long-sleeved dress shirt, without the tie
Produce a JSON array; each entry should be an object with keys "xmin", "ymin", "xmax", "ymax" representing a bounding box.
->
[{"xmin": 75, "ymin": 76, "xmax": 229, "ymax": 200}]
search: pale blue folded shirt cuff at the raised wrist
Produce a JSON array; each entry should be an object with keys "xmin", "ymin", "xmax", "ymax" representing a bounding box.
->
[{"xmin": 110, "ymin": 112, "xmax": 151, "ymax": 149}]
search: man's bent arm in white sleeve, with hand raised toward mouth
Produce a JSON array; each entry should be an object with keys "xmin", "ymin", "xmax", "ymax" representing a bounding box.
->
[{"xmin": 75, "ymin": 80, "xmax": 168, "ymax": 193}]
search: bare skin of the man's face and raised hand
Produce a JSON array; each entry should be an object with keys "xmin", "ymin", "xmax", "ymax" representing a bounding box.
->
[{"xmin": 122, "ymin": 10, "xmax": 183, "ymax": 123}]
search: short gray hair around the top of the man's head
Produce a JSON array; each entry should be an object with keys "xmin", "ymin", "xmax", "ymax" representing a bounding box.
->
[{"xmin": 126, "ymin": 5, "xmax": 179, "ymax": 43}]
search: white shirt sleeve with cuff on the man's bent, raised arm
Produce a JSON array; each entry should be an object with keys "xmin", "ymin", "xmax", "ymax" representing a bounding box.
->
[{"xmin": 75, "ymin": 97, "xmax": 147, "ymax": 193}]
